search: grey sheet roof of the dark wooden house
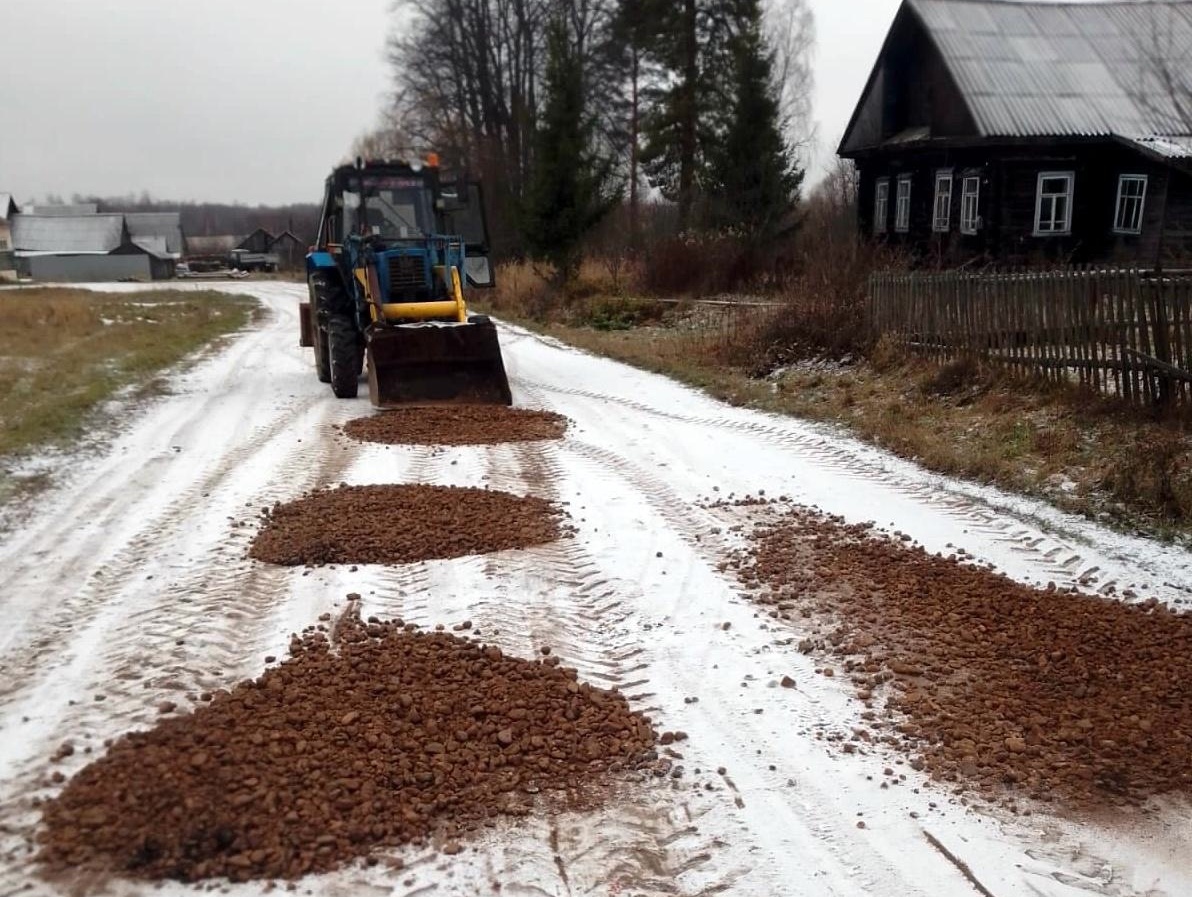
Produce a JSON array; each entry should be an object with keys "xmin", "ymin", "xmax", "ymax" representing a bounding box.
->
[{"xmin": 906, "ymin": 0, "xmax": 1192, "ymax": 139}]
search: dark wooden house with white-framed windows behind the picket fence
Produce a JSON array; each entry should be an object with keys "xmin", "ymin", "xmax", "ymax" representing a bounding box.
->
[{"xmin": 839, "ymin": 0, "xmax": 1192, "ymax": 268}]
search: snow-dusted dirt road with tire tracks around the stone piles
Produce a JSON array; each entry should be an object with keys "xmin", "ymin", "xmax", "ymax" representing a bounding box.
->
[{"xmin": 0, "ymin": 284, "xmax": 1192, "ymax": 897}]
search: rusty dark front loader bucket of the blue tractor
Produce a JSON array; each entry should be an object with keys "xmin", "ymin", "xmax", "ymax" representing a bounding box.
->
[{"xmin": 367, "ymin": 320, "xmax": 513, "ymax": 407}]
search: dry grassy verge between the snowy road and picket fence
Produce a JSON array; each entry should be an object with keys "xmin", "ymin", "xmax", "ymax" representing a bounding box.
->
[{"xmin": 483, "ymin": 291, "xmax": 1192, "ymax": 541}]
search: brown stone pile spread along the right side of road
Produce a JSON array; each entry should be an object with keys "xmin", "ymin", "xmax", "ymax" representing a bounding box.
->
[{"xmin": 733, "ymin": 509, "xmax": 1192, "ymax": 804}]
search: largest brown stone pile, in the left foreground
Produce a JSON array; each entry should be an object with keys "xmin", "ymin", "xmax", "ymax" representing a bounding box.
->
[{"xmin": 39, "ymin": 617, "xmax": 656, "ymax": 882}]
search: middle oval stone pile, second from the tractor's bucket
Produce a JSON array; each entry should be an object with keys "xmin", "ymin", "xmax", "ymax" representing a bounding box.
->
[{"xmin": 249, "ymin": 485, "xmax": 565, "ymax": 566}]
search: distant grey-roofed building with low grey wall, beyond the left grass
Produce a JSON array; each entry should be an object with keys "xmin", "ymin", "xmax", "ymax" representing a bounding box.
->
[{"xmin": 12, "ymin": 214, "xmax": 174, "ymax": 282}]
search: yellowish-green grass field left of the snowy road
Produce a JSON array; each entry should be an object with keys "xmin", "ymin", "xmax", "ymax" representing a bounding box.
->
[{"xmin": 0, "ymin": 288, "xmax": 255, "ymax": 459}]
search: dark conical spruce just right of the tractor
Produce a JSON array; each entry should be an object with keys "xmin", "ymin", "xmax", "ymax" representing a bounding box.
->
[{"xmin": 522, "ymin": 18, "xmax": 620, "ymax": 284}]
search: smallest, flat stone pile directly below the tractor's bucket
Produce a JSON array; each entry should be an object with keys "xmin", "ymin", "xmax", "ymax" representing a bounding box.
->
[{"xmin": 343, "ymin": 405, "xmax": 567, "ymax": 446}]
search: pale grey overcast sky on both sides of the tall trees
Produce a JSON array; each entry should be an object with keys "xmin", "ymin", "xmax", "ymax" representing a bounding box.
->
[{"xmin": 0, "ymin": 0, "xmax": 899, "ymax": 205}]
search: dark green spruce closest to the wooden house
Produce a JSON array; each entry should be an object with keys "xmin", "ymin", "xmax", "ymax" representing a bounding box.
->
[{"xmin": 707, "ymin": 0, "xmax": 803, "ymax": 241}]
